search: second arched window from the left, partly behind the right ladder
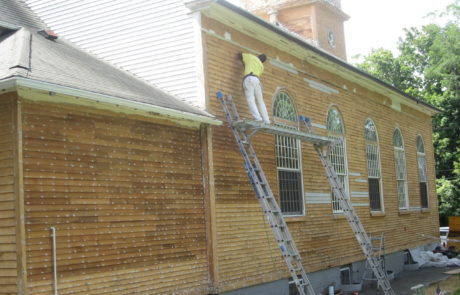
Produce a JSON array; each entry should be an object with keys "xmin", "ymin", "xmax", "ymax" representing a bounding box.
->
[{"xmin": 326, "ymin": 108, "xmax": 348, "ymax": 213}]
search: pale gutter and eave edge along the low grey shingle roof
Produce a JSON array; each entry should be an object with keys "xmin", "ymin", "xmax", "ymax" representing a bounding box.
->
[{"xmin": 0, "ymin": 77, "xmax": 222, "ymax": 125}]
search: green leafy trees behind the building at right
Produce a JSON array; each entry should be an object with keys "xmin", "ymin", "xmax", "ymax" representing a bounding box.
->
[{"xmin": 357, "ymin": 0, "xmax": 460, "ymax": 222}]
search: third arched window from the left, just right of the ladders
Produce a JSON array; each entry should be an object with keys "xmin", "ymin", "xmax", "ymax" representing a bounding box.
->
[{"xmin": 364, "ymin": 119, "xmax": 382, "ymax": 211}]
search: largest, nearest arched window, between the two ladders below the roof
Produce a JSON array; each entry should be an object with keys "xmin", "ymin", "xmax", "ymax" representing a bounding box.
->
[{"xmin": 273, "ymin": 91, "xmax": 304, "ymax": 215}]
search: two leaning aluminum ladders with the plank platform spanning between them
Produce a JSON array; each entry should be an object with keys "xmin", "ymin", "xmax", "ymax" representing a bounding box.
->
[{"xmin": 217, "ymin": 92, "xmax": 395, "ymax": 295}]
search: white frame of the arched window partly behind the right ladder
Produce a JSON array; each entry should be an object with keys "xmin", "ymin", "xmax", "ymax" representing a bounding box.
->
[{"xmin": 326, "ymin": 106, "xmax": 349, "ymax": 214}]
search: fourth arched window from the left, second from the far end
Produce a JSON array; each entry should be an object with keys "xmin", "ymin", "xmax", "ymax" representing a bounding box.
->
[{"xmin": 393, "ymin": 129, "xmax": 409, "ymax": 210}]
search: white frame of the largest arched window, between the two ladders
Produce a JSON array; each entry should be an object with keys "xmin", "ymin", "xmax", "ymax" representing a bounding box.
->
[{"xmin": 272, "ymin": 88, "xmax": 306, "ymax": 217}]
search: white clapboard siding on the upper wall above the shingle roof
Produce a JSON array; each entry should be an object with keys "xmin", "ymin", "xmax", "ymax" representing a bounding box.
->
[{"xmin": 25, "ymin": 0, "xmax": 202, "ymax": 105}]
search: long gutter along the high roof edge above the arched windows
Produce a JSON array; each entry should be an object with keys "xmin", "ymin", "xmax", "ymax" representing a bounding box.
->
[{"xmin": 214, "ymin": 0, "xmax": 442, "ymax": 112}]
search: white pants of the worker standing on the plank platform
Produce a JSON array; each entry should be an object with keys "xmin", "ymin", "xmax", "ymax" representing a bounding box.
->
[{"xmin": 243, "ymin": 76, "xmax": 270, "ymax": 124}]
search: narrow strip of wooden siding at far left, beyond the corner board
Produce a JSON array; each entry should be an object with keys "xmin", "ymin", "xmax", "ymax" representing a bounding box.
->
[{"xmin": 0, "ymin": 94, "xmax": 18, "ymax": 295}]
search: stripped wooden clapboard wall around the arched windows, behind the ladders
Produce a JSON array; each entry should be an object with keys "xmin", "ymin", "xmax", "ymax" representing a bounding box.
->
[{"xmin": 203, "ymin": 18, "xmax": 438, "ymax": 290}]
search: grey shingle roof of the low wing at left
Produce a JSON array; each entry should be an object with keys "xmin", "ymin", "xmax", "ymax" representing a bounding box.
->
[{"xmin": 0, "ymin": 0, "xmax": 212, "ymax": 121}]
